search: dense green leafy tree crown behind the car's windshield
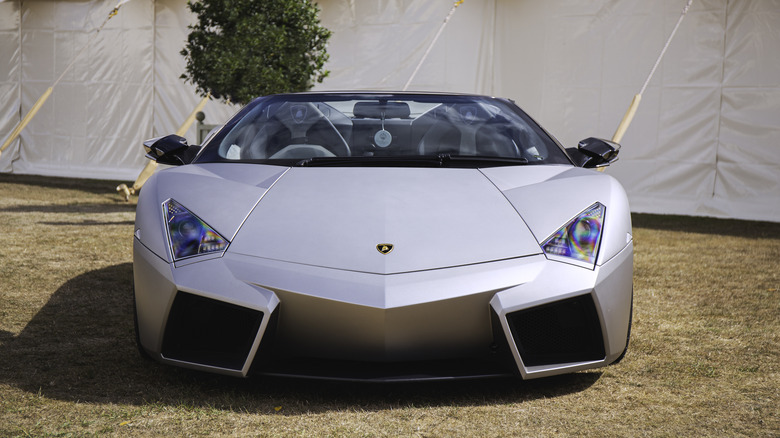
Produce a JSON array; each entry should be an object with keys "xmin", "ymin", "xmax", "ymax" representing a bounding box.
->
[{"xmin": 181, "ymin": 0, "xmax": 331, "ymax": 104}]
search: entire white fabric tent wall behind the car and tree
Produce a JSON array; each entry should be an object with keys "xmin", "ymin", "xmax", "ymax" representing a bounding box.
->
[{"xmin": 0, "ymin": 0, "xmax": 780, "ymax": 221}]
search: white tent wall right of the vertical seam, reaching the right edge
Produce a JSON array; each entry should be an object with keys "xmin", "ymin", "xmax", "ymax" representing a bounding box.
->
[{"xmin": 496, "ymin": 0, "xmax": 780, "ymax": 221}]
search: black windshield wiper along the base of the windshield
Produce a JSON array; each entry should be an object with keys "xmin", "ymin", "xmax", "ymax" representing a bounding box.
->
[{"xmin": 295, "ymin": 154, "xmax": 528, "ymax": 167}]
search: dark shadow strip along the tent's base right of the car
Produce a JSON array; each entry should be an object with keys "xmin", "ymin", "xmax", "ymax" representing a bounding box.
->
[{"xmin": 631, "ymin": 213, "xmax": 780, "ymax": 239}]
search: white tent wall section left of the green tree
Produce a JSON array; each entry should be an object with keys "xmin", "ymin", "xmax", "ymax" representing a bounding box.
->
[{"xmin": 0, "ymin": 0, "xmax": 234, "ymax": 181}]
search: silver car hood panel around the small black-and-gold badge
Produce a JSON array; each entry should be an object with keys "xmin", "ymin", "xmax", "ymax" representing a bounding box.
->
[{"xmin": 228, "ymin": 167, "xmax": 541, "ymax": 274}]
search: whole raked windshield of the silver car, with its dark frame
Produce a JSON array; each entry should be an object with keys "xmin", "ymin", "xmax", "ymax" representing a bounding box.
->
[{"xmin": 195, "ymin": 93, "xmax": 571, "ymax": 167}]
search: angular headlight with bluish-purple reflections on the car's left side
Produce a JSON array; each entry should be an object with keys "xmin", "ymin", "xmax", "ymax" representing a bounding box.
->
[{"xmin": 163, "ymin": 199, "xmax": 230, "ymax": 261}]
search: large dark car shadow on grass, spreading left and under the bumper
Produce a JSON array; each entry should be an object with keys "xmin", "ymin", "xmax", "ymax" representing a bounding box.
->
[{"xmin": 0, "ymin": 263, "xmax": 601, "ymax": 415}]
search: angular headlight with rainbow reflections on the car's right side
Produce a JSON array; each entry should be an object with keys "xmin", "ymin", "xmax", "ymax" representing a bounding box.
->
[{"xmin": 542, "ymin": 202, "xmax": 607, "ymax": 269}]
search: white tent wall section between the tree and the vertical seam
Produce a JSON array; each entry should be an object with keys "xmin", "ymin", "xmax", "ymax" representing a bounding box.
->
[{"xmin": 316, "ymin": 0, "xmax": 495, "ymax": 94}]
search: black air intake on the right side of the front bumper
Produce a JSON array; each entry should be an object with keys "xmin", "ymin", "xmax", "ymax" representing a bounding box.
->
[{"xmin": 507, "ymin": 295, "xmax": 605, "ymax": 366}]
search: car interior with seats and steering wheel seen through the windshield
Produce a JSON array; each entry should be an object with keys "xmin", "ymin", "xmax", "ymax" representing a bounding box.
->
[{"xmin": 219, "ymin": 100, "xmax": 547, "ymax": 161}]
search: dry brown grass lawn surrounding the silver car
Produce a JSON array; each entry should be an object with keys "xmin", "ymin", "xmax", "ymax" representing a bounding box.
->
[{"xmin": 0, "ymin": 175, "xmax": 780, "ymax": 436}]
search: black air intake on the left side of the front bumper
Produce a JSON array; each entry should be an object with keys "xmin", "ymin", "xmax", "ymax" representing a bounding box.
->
[{"xmin": 162, "ymin": 291, "xmax": 263, "ymax": 370}]
